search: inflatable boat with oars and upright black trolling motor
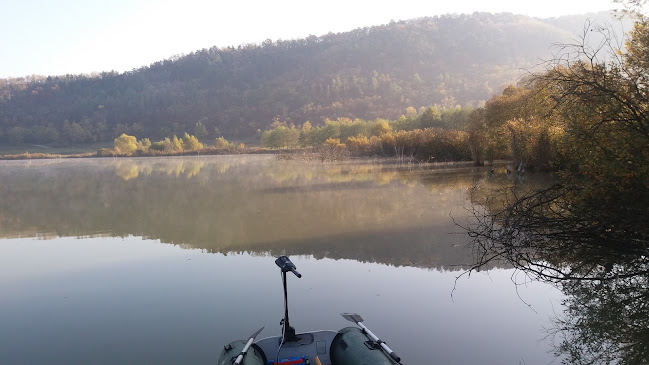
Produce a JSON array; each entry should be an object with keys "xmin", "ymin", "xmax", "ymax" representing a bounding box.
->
[{"xmin": 218, "ymin": 256, "xmax": 403, "ymax": 365}]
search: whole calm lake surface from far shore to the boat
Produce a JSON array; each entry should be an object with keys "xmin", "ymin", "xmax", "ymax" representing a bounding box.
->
[{"xmin": 0, "ymin": 156, "xmax": 562, "ymax": 364}]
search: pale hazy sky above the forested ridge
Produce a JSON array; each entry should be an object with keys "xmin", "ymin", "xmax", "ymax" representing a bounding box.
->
[{"xmin": 0, "ymin": 0, "xmax": 628, "ymax": 78}]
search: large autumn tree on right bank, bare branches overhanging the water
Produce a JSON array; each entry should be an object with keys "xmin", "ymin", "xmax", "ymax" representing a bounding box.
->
[{"xmin": 467, "ymin": 16, "xmax": 649, "ymax": 288}]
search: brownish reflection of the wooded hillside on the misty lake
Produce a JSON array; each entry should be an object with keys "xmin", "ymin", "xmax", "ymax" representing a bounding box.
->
[{"xmin": 0, "ymin": 156, "xmax": 548, "ymax": 269}]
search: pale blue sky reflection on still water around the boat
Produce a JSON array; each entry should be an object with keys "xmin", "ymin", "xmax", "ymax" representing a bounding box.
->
[{"xmin": 0, "ymin": 237, "xmax": 558, "ymax": 365}]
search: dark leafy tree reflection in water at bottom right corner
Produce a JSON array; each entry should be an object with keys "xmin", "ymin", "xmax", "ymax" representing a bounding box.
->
[{"xmin": 551, "ymin": 268, "xmax": 649, "ymax": 364}]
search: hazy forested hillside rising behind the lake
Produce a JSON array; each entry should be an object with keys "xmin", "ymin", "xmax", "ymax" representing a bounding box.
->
[{"xmin": 0, "ymin": 13, "xmax": 624, "ymax": 145}]
